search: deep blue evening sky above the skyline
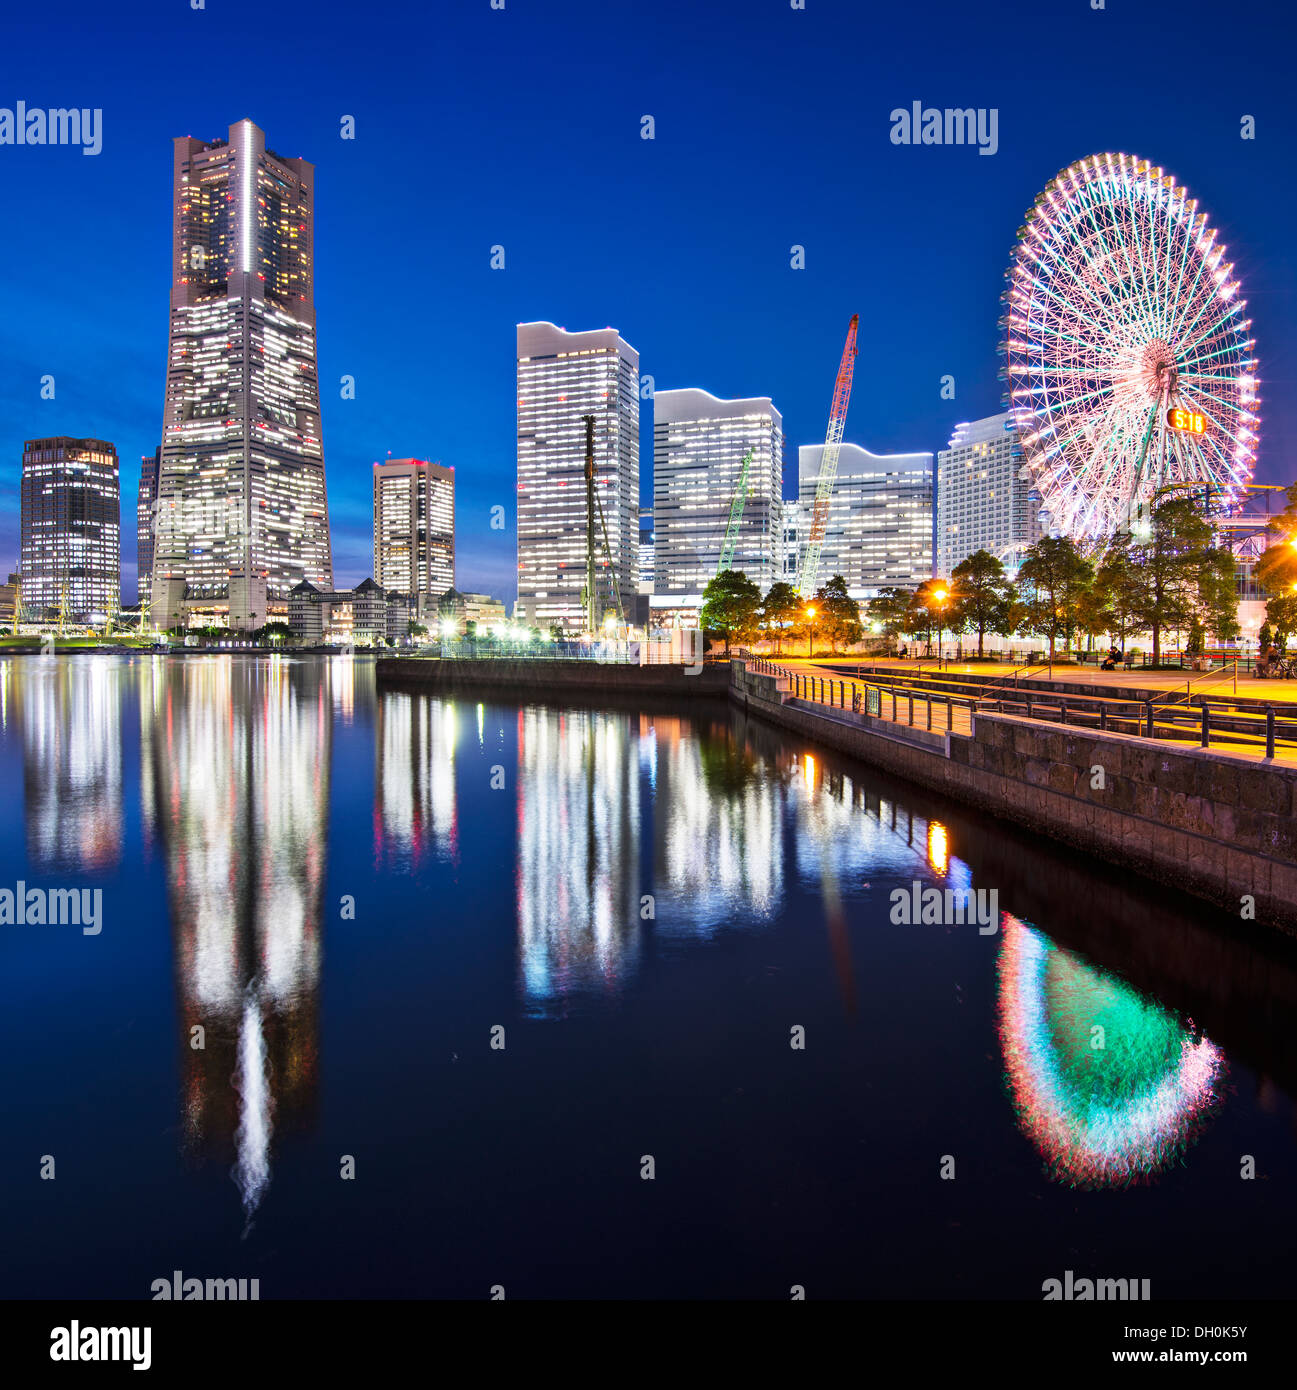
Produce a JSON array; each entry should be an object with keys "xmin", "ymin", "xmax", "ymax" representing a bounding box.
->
[{"xmin": 0, "ymin": 0, "xmax": 1297, "ymax": 598}]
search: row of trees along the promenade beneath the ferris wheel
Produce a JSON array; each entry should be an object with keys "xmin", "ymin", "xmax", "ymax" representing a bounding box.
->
[{"xmin": 869, "ymin": 495, "xmax": 1239, "ymax": 664}]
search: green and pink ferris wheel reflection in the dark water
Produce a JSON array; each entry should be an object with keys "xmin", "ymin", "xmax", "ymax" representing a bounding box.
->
[{"xmin": 998, "ymin": 913, "xmax": 1225, "ymax": 1188}]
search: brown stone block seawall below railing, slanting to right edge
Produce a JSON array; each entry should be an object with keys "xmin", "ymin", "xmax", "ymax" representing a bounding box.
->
[{"xmin": 730, "ymin": 662, "xmax": 1297, "ymax": 933}]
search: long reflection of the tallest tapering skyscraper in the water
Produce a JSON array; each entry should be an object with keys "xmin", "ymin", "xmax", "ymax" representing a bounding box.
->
[{"xmin": 140, "ymin": 657, "xmax": 323, "ymax": 1223}]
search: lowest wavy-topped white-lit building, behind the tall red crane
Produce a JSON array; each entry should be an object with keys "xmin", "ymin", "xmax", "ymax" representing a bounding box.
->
[{"xmin": 790, "ymin": 443, "xmax": 933, "ymax": 599}]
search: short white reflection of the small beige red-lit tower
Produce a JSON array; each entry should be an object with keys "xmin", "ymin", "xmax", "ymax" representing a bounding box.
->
[{"xmin": 374, "ymin": 691, "xmax": 458, "ymax": 867}]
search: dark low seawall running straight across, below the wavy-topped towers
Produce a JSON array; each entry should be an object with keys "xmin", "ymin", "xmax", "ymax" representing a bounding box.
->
[{"xmin": 375, "ymin": 656, "xmax": 730, "ymax": 702}]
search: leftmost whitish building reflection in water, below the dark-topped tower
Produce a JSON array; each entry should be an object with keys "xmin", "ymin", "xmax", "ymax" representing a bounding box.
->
[{"xmin": 14, "ymin": 655, "xmax": 128, "ymax": 872}]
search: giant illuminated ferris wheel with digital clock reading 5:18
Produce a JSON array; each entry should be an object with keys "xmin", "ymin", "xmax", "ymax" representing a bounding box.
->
[{"xmin": 1001, "ymin": 154, "xmax": 1259, "ymax": 539}]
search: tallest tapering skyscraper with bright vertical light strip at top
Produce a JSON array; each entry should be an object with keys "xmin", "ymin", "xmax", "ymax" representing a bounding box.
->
[{"xmin": 153, "ymin": 121, "xmax": 334, "ymax": 627}]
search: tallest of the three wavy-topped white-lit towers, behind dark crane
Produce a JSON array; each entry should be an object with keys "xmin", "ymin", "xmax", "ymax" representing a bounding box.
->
[{"xmin": 517, "ymin": 322, "xmax": 639, "ymax": 631}]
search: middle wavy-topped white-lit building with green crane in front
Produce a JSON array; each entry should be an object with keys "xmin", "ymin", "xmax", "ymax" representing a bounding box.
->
[{"xmin": 653, "ymin": 388, "xmax": 784, "ymax": 607}]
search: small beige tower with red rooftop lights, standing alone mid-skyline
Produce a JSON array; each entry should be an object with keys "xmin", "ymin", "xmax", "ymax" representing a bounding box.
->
[{"xmin": 374, "ymin": 459, "xmax": 455, "ymax": 595}]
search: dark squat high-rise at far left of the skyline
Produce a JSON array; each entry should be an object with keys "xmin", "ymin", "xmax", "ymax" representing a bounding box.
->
[{"xmin": 19, "ymin": 436, "xmax": 121, "ymax": 623}]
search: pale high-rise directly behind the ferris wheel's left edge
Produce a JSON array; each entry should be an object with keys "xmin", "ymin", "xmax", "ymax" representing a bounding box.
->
[{"xmin": 937, "ymin": 414, "xmax": 1048, "ymax": 580}]
